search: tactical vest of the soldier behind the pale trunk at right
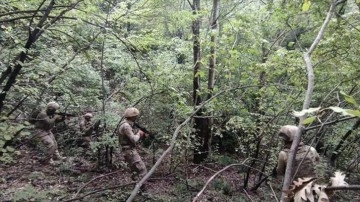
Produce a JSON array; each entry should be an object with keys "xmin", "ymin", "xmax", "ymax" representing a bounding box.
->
[{"xmin": 283, "ymin": 145, "xmax": 316, "ymax": 179}]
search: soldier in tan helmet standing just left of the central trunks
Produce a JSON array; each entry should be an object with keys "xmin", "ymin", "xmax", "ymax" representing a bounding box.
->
[{"xmin": 117, "ymin": 107, "xmax": 148, "ymax": 180}]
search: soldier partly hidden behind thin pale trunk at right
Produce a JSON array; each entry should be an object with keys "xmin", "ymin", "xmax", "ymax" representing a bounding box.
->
[{"xmin": 276, "ymin": 125, "xmax": 320, "ymax": 179}]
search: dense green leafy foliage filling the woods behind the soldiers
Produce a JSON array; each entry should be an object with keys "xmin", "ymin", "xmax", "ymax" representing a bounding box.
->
[{"xmin": 0, "ymin": 0, "xmax": 360, "ymax": 200}]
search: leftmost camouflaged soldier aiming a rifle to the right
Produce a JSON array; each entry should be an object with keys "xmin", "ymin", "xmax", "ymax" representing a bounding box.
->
[{"xmin": 35, "ymin": 102, "xmax": 65, "ymax": 164}]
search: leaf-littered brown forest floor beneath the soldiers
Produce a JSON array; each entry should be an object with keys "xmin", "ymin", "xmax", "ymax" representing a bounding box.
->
[{"xmin": 0, "ymin": 142, "xmax": 278, "ymax": 202}]
